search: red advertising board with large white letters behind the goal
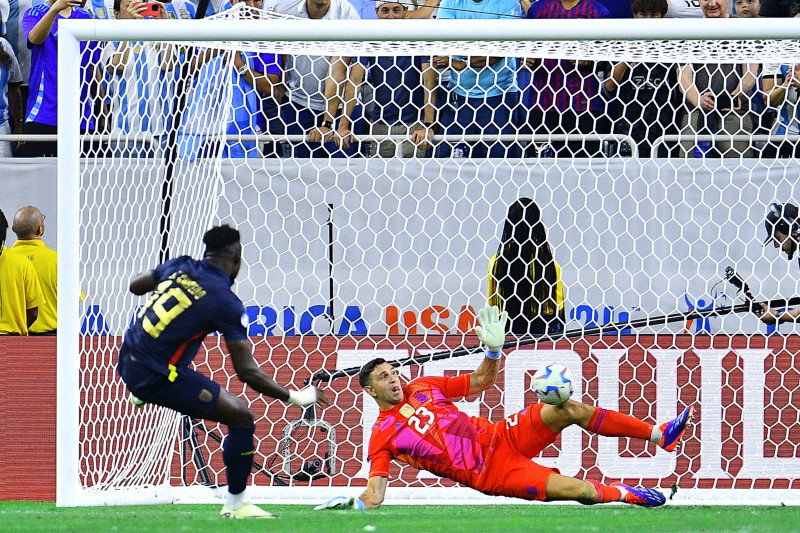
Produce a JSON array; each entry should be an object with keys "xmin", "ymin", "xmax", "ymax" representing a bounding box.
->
[{"xmin": 0, "ymin": 335, "xmax": 800, "ymax": 500}]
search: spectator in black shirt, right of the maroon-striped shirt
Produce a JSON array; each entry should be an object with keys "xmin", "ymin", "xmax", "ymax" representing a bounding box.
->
[{"xmin": 604, "ymin": 0, "xmax": 680, "ymax": 157}]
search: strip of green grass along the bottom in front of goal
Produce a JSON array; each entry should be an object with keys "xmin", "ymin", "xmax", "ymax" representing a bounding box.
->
[{"xmin": 0, "ymin": 502, "xmax": 800, "ymax": 533}]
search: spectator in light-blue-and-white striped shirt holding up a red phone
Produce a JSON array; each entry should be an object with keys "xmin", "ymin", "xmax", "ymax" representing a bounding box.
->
[{"xmin": 101, "ymin": 0, "xmax": 178, "ymax": 157}]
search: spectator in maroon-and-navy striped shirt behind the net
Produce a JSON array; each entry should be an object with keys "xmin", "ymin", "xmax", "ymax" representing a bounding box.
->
[{"xmin": 523, "ymin": 0, "xmax": 611, "ymax": 157}]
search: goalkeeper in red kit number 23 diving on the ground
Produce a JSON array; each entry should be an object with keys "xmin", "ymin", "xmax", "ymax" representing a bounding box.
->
[{"xmin": 316, "ymin": 307, "xmax": 692, "ymax": 510}]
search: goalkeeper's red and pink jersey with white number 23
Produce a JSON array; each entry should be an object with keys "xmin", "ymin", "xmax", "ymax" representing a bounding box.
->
[{"xmin": 369, "ymin": 374, "xmax": 495, "ymax": 486}]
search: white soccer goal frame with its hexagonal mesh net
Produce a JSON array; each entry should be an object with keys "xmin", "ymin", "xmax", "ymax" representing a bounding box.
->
[{"xmin": 57, "ymin": 6, "xmax": 800, "ymax": 505}]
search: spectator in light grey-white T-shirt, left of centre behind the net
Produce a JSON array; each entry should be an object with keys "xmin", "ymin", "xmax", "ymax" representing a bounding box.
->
[{"xmin": 264, "ymin": 0, "xmax": 361, "ymax": 157}]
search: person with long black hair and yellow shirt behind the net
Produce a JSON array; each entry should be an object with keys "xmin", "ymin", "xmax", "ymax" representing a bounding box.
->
[{"xmin": 489, "ymin": 198, "xmax": 566, "ymax": 336}]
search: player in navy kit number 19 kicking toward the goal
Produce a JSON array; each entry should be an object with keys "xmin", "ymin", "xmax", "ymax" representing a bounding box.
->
[{"xmin": 117, "ymin": 225, "xmax": 330, "ymax": 518}]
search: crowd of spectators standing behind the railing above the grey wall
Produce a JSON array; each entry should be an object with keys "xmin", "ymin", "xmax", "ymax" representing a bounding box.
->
[{"xmin": 0, "ymin": 0, "xmax": 800, "ymax": 159}]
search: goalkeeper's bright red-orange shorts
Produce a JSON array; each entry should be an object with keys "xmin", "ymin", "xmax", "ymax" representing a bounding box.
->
[{"xmin": 473, "ymin": 403, "xmax": 559, "ymax": 500}]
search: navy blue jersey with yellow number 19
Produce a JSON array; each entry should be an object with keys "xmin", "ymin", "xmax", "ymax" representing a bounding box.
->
[{"xmin": 122, "ymin": 256, "xmax": 247, "ymax": 380}]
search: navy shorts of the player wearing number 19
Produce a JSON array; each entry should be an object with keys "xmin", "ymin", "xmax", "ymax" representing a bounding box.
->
[{"xmin": 117, "ymin": 348, "xmax": 220, "ymax": 418}]
